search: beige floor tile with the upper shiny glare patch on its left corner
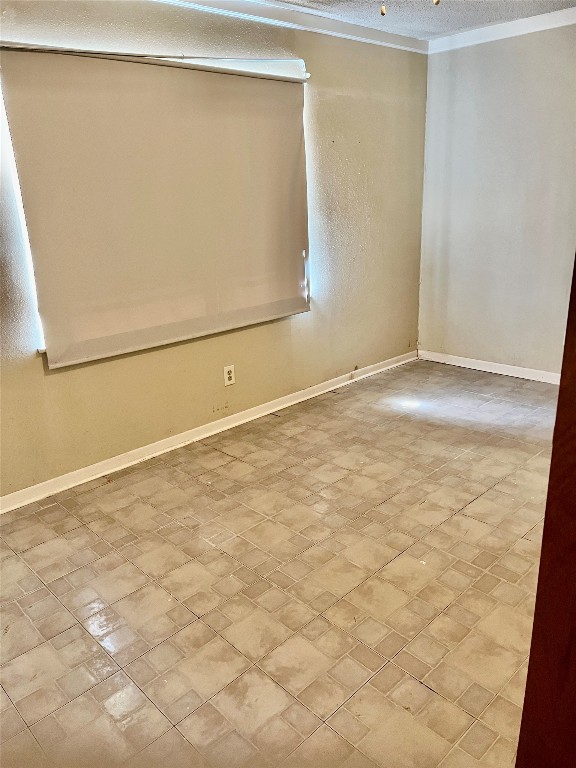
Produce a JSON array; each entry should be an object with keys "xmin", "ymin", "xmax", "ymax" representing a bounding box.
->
[{"xmin": 82, "ymin": 584, "xmax": 196, "ymax": 667}]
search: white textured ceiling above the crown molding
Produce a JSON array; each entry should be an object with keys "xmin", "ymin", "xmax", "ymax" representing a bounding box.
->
[{"xmin": 259, "ymin": 0, "xmax": 576, "ymax": 40}]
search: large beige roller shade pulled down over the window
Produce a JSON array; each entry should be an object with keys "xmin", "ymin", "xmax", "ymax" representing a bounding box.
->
[{"xmin": 2, "ymin": 51, "xmax": 309, "ymax": 368}]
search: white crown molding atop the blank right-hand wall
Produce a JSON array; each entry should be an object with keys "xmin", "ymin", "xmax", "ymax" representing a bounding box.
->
[{"xmin": 428, "ymin": 8, "xmax": 576, "ymax": 55}]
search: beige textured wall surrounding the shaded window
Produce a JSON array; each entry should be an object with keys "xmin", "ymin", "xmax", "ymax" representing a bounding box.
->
[{"xmin": 1, "ymin": 0, "xmax": 427, "ymax": 494}]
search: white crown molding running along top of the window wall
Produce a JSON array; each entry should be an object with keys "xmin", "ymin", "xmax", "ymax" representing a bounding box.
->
[{"xmin": 154, "ymin": 0, "xmax": 428, "ymax": 55}]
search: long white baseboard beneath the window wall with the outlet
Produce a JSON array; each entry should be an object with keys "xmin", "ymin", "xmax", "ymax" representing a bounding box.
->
[{"xmin": 0, "ymin": 352, "xmax": 418, "ymax": 512}]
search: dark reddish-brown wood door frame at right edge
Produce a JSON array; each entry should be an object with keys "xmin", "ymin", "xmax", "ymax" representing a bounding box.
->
[{"xmin": 516, "ymin": 255, "xmax": 576, "ymax": 768}]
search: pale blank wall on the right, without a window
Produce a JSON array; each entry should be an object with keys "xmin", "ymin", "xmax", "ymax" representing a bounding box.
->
[{"xmin": 419, "ymin": 26, "xmax": 576, "ymax": 373}]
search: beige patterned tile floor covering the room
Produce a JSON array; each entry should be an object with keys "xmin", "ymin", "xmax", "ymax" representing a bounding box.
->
[{"xmin": 0, "ymin": 361, "xmax": 557, "ymax": 768}]
